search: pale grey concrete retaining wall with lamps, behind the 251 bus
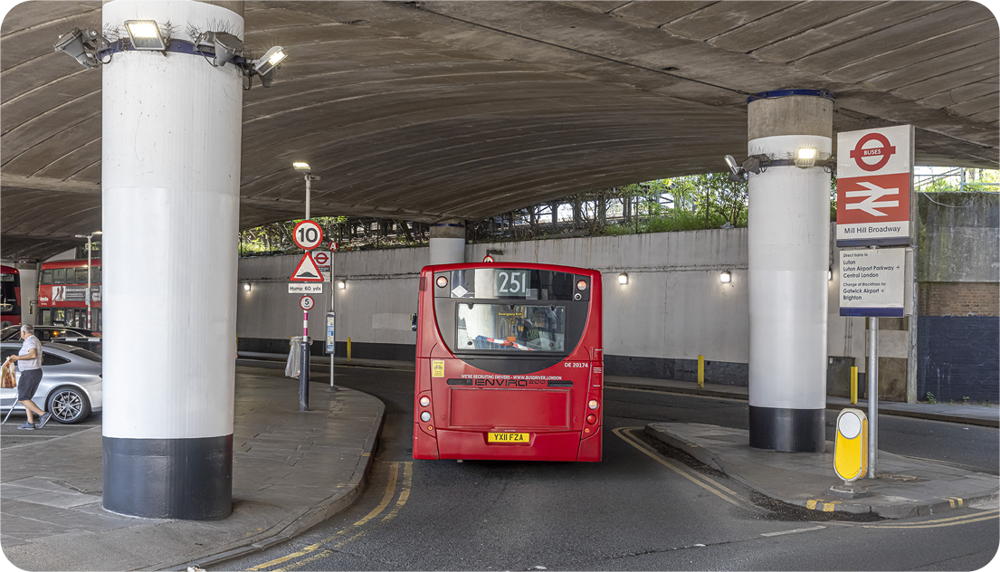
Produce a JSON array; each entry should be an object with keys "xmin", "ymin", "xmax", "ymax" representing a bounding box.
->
[{"xmin": 237, "ymin": 229, "xmax": 865, "ymax": 385}]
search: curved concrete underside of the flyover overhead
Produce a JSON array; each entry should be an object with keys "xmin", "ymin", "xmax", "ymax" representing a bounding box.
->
[{"xmin": 0, "ymin": 0, "xmax": 1000, "ymax": 259}]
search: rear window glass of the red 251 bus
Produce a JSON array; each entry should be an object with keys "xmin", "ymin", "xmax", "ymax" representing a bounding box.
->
[{"xmin": 455, "ymin": 303, "xmax": 566, "ymax": 352}]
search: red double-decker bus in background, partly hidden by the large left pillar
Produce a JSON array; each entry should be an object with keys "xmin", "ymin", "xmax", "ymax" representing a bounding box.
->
[{"xmin": 38, "ymin": 258, "xmax": 102, "ymax": 332}]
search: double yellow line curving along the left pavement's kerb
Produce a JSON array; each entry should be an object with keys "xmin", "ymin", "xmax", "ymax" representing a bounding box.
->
[{"xmin": 244, "ymin": 462, "xmax": 413, "ymax": 572}]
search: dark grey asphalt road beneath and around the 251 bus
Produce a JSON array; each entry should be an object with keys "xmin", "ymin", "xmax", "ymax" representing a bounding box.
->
[{"xmin": 210, "ymin": 367, "xmax": 1000, "ymax": 572}]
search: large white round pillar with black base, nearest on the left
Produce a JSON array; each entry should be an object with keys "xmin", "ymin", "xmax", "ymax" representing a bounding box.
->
[{"xmin": 102, "ymin": 0, "xmax": 243, "ymax": 520}]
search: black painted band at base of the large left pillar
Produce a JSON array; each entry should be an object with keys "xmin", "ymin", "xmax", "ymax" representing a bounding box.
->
[{"xmin": 103, "ymin": 435, "xmax": 233, "ymax": 520}]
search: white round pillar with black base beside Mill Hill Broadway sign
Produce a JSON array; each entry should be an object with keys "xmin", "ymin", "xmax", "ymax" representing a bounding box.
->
[{"xmin": 748, "ymin": 90, "xmax": 833, "ymax": 452}]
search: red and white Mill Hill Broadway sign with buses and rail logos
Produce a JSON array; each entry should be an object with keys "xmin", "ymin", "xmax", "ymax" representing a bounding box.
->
[{"xmin": 837, "ymin": 125, "xmax": 913, "ymax": 247}]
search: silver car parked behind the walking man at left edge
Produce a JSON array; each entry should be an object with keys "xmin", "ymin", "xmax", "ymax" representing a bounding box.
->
[{"xmin": 0, "ymin": 342, "xmax": 102, "ymax": 423}]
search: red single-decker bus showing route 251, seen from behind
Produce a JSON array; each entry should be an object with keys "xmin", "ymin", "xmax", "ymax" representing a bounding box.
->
[{"xmin": 413, "ymin": 264, "xmax": 604, "ymax": 461}]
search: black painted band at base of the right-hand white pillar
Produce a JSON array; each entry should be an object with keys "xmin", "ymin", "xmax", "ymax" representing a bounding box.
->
[{"xmin": 750, "ymin": 405, "xmax": 826, "ymax": 453}]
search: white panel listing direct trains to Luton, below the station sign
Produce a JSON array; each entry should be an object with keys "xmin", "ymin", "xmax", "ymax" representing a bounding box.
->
[{"xmin": 840, "ymin": 248, "xmax": 906, "ymax": 318}]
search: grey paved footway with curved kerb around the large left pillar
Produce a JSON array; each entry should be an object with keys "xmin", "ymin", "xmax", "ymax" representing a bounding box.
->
[{"xmin": 0, "ymin": 368, "xmax": 385, "ymax": 572}]
